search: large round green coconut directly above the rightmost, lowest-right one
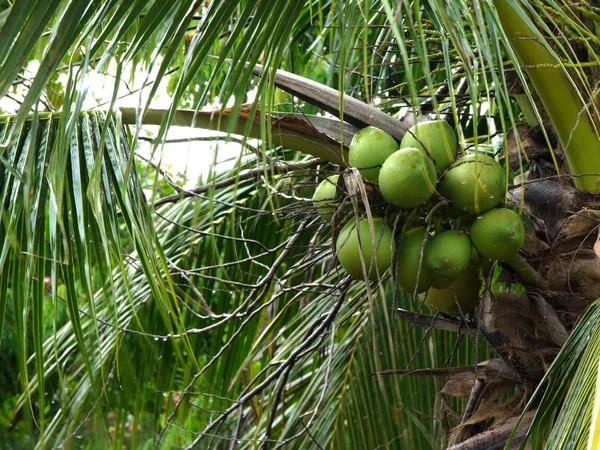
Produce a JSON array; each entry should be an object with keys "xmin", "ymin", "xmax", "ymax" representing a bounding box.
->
[{"xmin": 440, "ymin": 154, "xmax": 506, "ymax": 214}]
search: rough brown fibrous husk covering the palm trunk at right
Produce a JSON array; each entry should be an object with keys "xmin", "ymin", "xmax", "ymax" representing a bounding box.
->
[{"xmin": 436, "ymin": 130, "xmax": 600, "ymax": 442}]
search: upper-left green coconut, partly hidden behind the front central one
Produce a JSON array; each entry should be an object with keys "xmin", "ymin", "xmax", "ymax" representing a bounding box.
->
[{"xmin": 348, "ymin": 127, "xmax": 398, "ymax": 183}]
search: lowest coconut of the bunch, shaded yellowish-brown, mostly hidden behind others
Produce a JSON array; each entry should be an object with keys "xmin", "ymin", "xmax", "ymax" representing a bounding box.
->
[{"xmin": 425, "ymin": 263, "xmax": 481, "ymax": 316}]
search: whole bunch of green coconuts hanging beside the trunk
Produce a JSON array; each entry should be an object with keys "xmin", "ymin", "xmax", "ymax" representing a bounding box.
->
[{"xmin": 313, "ymin": 120, "xmax": 525, "ymax": 316}]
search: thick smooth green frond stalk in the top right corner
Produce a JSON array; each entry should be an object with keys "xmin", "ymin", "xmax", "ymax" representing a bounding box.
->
[{"xmin": 494, "ymin": 0, "xmax": 600, "ymax": 193}]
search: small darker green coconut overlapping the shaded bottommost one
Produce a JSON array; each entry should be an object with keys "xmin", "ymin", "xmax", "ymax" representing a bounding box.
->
[{"xmin": 424, "ymin": 230, "xmax": 472, "ymax": 278}]
